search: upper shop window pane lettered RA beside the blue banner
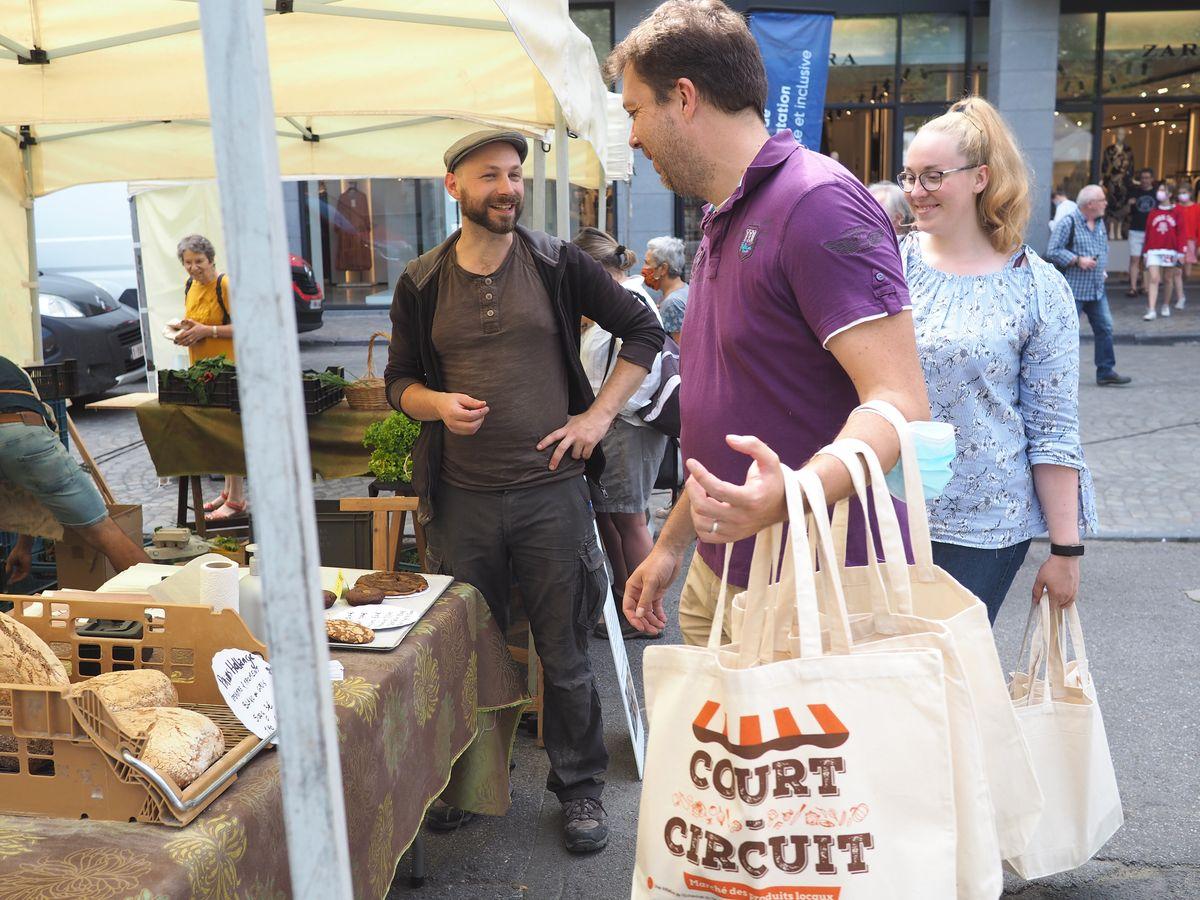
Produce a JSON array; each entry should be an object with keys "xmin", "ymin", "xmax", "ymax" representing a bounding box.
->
[{"xmin": 826, "ymin": 16, "xmax": 897, "ymax": 107}]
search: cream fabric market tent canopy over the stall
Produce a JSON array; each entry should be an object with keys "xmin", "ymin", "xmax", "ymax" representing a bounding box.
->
[{"xmin": 0, "ymin": 0, "xmax": 630, "ymax": 361}]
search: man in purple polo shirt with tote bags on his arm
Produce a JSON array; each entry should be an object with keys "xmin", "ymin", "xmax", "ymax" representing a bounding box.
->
[{"xmin": 608, "ymin": 0, "xmax": 929, "ymax": 644}]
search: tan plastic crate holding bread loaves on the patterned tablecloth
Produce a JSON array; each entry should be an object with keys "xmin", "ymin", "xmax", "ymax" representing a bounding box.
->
[{"xmin": 0, "ymin": 593, "xmax": 266, "ymax": 830}]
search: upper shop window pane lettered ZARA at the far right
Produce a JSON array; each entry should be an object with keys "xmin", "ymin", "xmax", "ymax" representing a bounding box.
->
[{"xmin": 1103, "ymin": 11, "xmax": 1200, "ymax": 100}]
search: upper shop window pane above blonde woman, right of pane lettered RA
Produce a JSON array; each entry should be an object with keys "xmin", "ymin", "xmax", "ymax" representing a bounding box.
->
[{"xmin": 900, "ymin": 13, "xmax": 967, "ymax": 103}]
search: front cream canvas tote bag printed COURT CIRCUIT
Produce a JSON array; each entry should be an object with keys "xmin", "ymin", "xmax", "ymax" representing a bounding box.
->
[{"xmin": 632, "ymin": 473, "xmax": 955, "ymax": 900}]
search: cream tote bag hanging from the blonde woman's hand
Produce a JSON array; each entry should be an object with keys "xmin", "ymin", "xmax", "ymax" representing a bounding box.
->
[{"xmin": 1006, "ymin": 596, "xmax": 1124, "ymax": 878}]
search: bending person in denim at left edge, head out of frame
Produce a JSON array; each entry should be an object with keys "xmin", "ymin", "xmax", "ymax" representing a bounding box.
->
[{"xmin": 0, "ymin": 356, "xmax": 150, "ymax": 583}]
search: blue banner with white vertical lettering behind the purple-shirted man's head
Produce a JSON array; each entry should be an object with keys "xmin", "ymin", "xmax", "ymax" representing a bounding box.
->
[{"xmin": 750, "ymin": 12, "xmax": 833, "ymax": 150}]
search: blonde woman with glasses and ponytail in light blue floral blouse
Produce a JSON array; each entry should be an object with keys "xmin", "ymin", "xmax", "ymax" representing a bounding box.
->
[{"xmin": 896, "ymin": 97, "xmax": 1096, "ymax": 622}]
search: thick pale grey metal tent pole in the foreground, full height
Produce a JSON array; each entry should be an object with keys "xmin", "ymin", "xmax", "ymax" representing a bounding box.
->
[{"xmin": 200, "ymin": 0, "xmax": 354, "ymax": 900}]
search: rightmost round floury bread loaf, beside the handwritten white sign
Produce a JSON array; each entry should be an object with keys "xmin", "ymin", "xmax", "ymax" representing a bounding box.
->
[{"xmin": 114, "ymin": 707, "xmax": 224, "ymax": 787}]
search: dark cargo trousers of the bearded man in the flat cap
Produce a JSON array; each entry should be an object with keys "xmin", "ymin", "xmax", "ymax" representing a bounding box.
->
[{"xmin": 426, "ymin": 475, "xmax": 608, "ymax": 802}]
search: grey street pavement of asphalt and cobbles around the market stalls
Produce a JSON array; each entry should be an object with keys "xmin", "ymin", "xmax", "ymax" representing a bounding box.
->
[{"xmin": 58, "ymin": 307, "xmax": 1200, "ymax": 900}]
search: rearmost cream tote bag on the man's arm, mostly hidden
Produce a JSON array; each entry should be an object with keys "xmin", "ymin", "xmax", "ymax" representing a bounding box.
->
[{"xmin": 834, "ymin": 401, "xmax": 1043, "ymax": 857}]
